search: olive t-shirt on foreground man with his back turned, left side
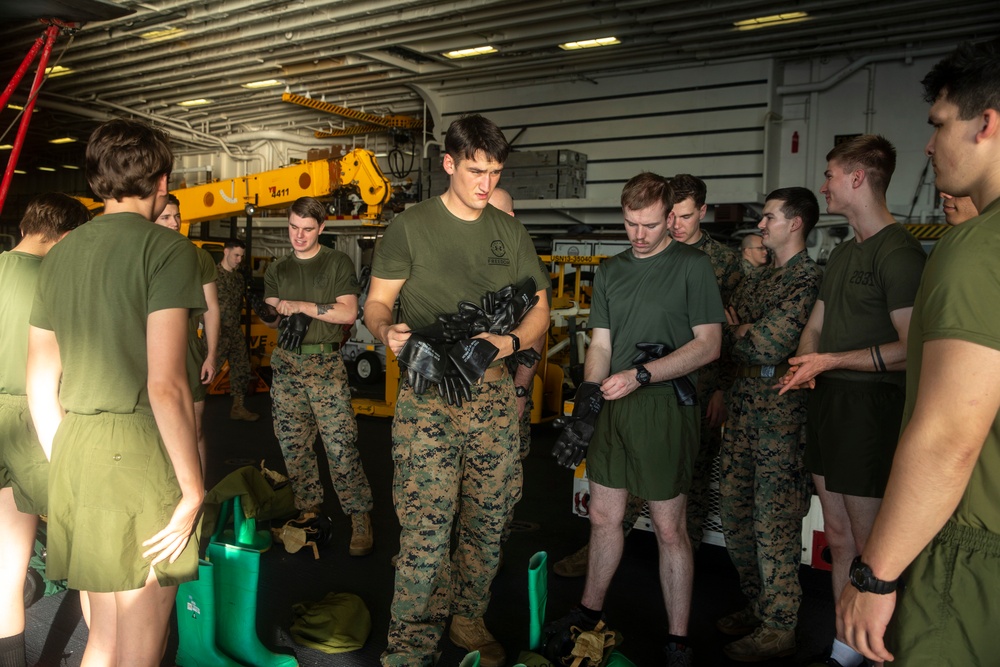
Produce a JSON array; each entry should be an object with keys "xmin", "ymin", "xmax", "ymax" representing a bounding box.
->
[{"xmin": 30, "ymin": 213, "xmax": 205, "ymax": 414}]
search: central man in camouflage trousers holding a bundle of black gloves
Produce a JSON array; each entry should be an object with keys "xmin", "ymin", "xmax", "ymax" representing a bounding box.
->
[{"xmin": 365, "ymin": 115, "xmax": 549, "ymax": 667}]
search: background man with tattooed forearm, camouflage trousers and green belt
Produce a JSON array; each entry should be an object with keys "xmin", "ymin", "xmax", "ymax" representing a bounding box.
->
[{"xmin": 264, "ymin": 197, "xmax": 373, "ymax": 556}]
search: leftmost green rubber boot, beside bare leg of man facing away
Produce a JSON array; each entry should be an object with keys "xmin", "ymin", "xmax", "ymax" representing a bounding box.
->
[{"xmin": 175, "ymin": 560, "xmax": 242, "ymax": 667}]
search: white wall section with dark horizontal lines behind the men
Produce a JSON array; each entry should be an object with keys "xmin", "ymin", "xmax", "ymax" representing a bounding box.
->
[{"xmin": 438, "ymin": 61, "xmax": 772, "ymax": 210}]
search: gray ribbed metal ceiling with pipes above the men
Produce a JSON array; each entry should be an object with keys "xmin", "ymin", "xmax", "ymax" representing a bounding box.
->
[{"xmin": 0, "ymin": 0, "xmax": 1000, "ymax": 172}]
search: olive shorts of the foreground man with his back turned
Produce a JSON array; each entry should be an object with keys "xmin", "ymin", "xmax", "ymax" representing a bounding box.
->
[{"xmin": 47, "ymin": 412, "xmax": 199, "ymax": 593}]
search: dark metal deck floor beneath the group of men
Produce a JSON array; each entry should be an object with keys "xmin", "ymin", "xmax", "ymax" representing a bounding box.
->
[{"xmin": 26, "ymin": 394, "xmax": 833, "ymax": 667}]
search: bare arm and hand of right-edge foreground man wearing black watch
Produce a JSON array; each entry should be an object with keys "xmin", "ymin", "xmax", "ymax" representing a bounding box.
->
[{"xmin": 837, "ymin": 340, "xmax": 1000, "ymax": 661}]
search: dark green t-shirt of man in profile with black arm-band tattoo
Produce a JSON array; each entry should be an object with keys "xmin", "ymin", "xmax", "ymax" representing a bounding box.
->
[{"xmin": 819, "ymin": 224, "xmax": 926, "ymax": 385}]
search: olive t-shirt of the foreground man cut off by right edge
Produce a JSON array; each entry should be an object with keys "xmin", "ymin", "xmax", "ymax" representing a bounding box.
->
[{"xmin": 902, "ymin": 199, "xmax": 1000, "ymax": 535}]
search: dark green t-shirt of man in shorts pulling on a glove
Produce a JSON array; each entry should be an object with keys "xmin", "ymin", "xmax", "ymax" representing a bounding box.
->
[{"xmin": 590, "ymin": 241, "xmax": 726, "ymax": 382}]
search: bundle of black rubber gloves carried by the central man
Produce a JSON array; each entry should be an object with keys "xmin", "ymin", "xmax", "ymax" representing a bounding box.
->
[{"xmin": 399, "ymin": 278, "xmax": 539, "ymax": 407}]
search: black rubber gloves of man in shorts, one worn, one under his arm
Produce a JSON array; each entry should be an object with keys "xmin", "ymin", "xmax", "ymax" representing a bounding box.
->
[{"xmin": 552, "ymin": 343, "xmax": 697, "ymax": 468}]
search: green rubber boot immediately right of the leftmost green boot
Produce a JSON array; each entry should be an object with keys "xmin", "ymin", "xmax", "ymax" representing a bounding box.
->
[{"xmin": 208, "ymin": 542, "xmax": 299, "ymax": 667}]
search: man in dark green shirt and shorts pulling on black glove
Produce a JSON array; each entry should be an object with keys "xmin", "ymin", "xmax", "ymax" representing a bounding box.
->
[{"xmin": 546, "ymin": 172, "xmax": 726, "ymax": 665}]
